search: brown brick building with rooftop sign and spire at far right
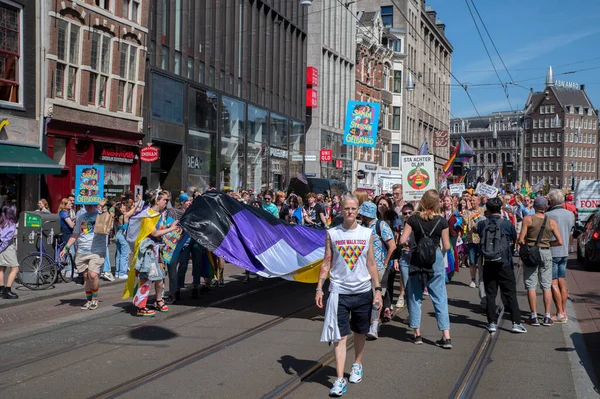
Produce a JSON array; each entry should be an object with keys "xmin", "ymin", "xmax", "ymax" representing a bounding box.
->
[{"xmin": 524, "ymin": 68, "xmax": 599, "ymax": 190}]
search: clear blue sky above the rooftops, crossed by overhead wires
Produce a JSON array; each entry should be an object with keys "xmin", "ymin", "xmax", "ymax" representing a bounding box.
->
[{"xmin": 426, "ymin": 0, "xmax": 600, "ymax": 118}]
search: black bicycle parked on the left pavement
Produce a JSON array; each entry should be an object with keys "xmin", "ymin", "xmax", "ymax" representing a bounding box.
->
[{"xmin": 17, "ymin": 221, "xmax": 75, "ymax": 290}]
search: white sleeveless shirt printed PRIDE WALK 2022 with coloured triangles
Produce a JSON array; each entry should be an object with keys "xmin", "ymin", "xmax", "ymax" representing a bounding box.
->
[{"xmin": 327, "ymin": 225, "xmax": 372, "ymax": 294}]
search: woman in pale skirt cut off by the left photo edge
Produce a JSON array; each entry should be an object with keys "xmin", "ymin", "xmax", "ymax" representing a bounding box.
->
[{"xmin": 0, "ymin": 205, "xmax": 19, "ymax": 299}]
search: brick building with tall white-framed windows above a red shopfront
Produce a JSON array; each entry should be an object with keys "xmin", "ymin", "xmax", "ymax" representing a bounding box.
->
[{"xmin": 42, "ymin": 0, "xmax": 148, "ymax": 210}]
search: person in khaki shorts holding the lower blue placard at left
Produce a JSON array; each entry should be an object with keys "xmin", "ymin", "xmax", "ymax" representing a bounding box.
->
[{"xmin": 60, "ymin": 205, "xmax": 106, "ymax": 310}]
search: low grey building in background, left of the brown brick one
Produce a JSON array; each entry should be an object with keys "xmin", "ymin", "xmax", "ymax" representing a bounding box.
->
[{"xmin": 450, "ymin": 112, "xmax": 523, "ymax": 184}]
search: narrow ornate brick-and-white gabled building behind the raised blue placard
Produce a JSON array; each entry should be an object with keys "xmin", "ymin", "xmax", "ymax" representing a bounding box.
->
[{"xmin": 352, "ymin": 11, "xmax": 404, "ymax": 194}]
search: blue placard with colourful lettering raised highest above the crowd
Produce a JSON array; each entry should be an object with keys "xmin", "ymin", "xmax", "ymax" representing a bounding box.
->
[{"xmin": 343, "ymin": 101, "xmax": 380, "ymax": 147}]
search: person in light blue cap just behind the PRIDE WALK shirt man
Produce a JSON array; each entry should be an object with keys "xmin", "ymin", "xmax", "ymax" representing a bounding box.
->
[{"xmin": 358, "ymin": 201, "xmax": 399, "ymax": 339}]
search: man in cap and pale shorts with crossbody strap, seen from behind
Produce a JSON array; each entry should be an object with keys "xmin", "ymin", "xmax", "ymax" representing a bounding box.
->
[{"xmin": 519, "ymin": 196, "xmax": 563, "ymax": 327}]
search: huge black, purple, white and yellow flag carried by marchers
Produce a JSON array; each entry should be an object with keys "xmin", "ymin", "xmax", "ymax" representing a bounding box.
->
[{"xmin": 180, "ymin": 191, "xmax": 325, "ymax": 283}]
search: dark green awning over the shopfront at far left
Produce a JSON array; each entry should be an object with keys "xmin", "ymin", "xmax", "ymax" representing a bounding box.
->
[{"xmin": 0, "ymin": 144, "xmax": 63, "ymax": 175}]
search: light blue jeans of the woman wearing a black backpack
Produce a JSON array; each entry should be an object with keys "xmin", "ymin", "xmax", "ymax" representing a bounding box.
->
[{"xmin": 407, "ymin": 250, "xmax": 450, "ymax": 331}]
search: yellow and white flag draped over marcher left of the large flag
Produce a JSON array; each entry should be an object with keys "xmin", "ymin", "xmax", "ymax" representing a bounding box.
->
[{"xmin": 122, "ymin": 207, "xmax": 160, "ymax": 299}]
